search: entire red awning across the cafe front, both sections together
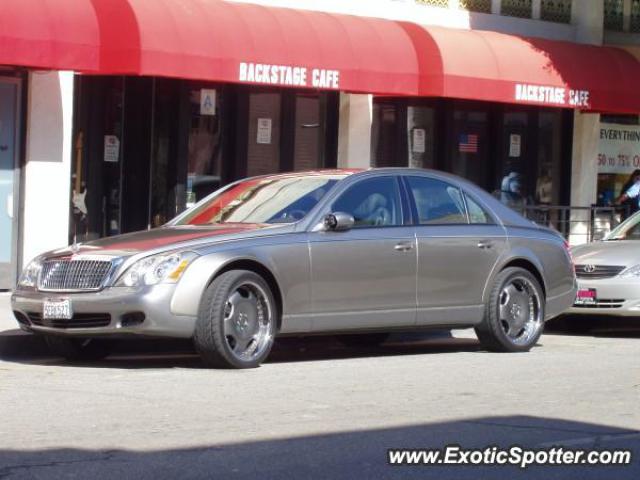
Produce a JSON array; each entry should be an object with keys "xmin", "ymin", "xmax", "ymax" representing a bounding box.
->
[{"xmin": 0, "ymin": 0, "xmax": 640, "ymax": 113}]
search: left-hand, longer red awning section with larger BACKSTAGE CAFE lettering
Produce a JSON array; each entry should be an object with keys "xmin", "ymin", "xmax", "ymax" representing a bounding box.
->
[{"xmin": 0, "ymin": 0, "xmax": 418, "ymax": 95}]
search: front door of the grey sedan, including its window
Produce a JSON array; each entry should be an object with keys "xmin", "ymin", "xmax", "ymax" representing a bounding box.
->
[{"xmin": 309, "ymin": 175, "xmax": 416, "ymax": 331}]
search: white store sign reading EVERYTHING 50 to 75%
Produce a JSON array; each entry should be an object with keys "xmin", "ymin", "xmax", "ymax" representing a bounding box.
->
[{"xmin": 596, "ymin": 123, "xmax": 640, "ymax": 175}]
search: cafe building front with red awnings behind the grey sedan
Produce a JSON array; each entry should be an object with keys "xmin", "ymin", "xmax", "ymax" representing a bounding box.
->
[{"xmin": 0, "ymin": 0, "xmax": 640, "ymax": 288}]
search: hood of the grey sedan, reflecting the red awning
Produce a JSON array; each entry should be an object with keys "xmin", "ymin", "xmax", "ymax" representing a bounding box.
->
[{"xmin": 50, "ymin": 223, "xmax": 293, "ymax": 257}]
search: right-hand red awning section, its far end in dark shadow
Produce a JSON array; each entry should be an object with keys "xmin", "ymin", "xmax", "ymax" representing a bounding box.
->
[{"xmin": 402, "ymin": 23, "xmax": 640, "ymax": 113}]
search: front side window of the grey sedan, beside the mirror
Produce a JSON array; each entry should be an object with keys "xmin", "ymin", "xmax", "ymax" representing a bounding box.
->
[{"xmin": 331, "ymin": 177, "xmax": 402, "ymax": 227}]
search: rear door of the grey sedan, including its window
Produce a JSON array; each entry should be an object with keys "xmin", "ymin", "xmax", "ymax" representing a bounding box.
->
[{"xmin": 405, "ymin": 176, "xmax": 506, "ymax": 325}]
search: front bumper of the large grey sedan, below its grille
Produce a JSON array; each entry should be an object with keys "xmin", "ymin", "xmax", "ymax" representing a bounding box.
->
[{"xmin": 11, "ymin": 285, "xmax": 196, "ymax": 338}]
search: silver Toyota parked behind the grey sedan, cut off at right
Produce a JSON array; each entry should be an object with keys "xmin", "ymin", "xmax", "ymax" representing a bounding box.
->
[{"xmin": 569, "ymin": 212, "xmax": 640, "ymax": 318}]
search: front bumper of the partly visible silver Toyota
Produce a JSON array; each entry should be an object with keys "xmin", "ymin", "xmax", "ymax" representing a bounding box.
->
[{"xmin": 566, "ymin": 277, "xmax": 640, "ymax": 317}]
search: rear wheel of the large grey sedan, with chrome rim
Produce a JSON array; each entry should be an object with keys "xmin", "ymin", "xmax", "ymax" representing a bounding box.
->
[{"xmin": 475, "ymin": 267, "xmax": 545, "ymax": 352}]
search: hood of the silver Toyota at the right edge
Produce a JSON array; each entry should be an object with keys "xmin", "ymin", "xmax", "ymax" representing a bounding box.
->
[{"xmin": 571, "ymin": 240, "xmax": 640, "ymax": 266}]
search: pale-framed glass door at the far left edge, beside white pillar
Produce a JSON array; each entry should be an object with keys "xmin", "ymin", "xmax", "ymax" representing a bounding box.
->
[{"xmin": 0, "ymin": 79, "xmax": 20, "ymax": 290}]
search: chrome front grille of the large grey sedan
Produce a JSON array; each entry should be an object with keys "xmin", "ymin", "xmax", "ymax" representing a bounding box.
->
[{"xmin": 38, "ymin": 257, "xmax": 113, "ymax": 292}]
